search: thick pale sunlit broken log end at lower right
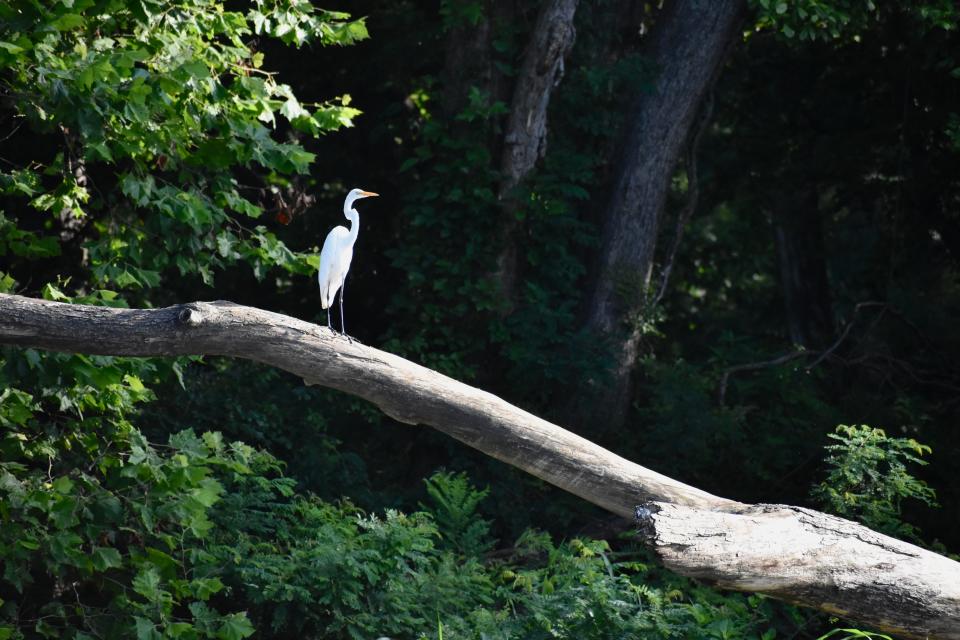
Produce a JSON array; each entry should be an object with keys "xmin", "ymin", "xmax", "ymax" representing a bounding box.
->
[{"xmin": 638, "ymin": 503, "xmax": 960, "ymax": 640}]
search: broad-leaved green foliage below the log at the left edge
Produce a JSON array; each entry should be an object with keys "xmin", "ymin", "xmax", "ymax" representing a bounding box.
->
[{"xmin": 0, "ymin": 328, "xmax": 271, "ymax": 638}]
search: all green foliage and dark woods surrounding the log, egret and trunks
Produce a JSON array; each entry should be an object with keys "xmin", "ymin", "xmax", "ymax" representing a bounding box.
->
[{"xmin": 0, "ymin": 0, "xmax": 960, "ymax": 640}]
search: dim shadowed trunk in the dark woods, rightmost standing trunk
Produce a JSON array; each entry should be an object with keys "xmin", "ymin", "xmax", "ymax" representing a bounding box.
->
[{"xmin": 773, "ymin": 190, "xmax": 834, "ymax": 348}]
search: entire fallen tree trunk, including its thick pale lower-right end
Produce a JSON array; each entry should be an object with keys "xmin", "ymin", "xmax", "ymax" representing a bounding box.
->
[{"xmin": 0, "ymin": 294, "xmax": 960, "ymax": 640}]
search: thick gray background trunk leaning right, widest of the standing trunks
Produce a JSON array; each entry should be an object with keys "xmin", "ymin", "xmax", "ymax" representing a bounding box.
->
[{"xmin": 587, "ymin": 0, "xmax": 746, "ymax": 428}]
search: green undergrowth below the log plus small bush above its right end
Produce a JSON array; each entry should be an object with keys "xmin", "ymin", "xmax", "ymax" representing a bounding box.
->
[{"xmin": 0, "ymin": 352, "xmax": 932, "ymax": 640}]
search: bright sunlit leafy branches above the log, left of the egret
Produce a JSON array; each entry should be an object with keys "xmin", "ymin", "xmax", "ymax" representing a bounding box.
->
[{"xmin": 0, "ymin": 0, "xmax": 367, "ymax": 289}]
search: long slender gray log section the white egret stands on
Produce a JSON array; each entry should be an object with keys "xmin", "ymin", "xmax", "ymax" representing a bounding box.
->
[{"xmin": 0, "ymin": 294, "xmax": 739, "ymax": 517}]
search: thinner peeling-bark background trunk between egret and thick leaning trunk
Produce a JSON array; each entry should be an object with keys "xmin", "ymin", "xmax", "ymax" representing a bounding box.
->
[{"xmin": 496, "ymin": 0, "xmax": 578, "ymax": 311}]
